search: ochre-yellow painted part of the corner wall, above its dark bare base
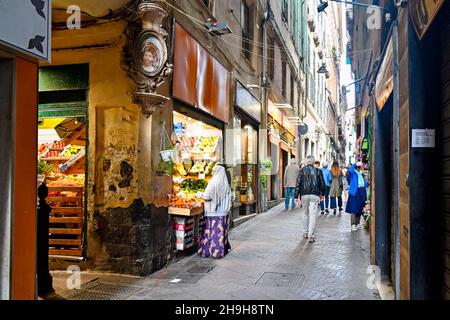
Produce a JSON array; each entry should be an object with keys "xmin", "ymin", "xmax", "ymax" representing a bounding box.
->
[{"xmin": 46, "ymin": 22, "xmax": 140, "ymax": 213}]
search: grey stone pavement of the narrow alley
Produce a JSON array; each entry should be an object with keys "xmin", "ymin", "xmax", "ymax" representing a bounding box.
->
[{"xmin": 53, "ymin": 205, "xmax": 380, "ymax": 300}]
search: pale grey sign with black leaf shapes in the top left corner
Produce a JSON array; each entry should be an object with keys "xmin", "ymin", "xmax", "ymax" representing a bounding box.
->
[{"xmin": 0, "ymin": 0, "xmax": 52, "ymax": 61}]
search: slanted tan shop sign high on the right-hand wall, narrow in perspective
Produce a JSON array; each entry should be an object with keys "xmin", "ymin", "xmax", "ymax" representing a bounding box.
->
[{"xmin": 375, "ymin": 37, "xmax": 394, "ymax": 111}]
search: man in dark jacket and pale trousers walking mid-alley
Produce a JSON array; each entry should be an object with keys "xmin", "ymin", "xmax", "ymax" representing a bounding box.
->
[{"xmin": 295, "ymin": 156, "xmax": 326, "ymax": 243}]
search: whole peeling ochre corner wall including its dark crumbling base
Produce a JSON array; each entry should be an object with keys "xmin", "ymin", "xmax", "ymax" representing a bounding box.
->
[{"xmin": 46, "ymin": 22, "xmax": 172, "ymax": 275}]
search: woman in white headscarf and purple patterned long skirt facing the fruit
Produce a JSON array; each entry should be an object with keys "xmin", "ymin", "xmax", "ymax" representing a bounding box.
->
[{"xmin": 198, "ymin": 165, "xmax": 231, "ymax": 258}]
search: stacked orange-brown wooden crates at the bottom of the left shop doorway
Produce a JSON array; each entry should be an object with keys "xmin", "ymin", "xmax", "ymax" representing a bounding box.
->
[{"xmin": 47, "ymin": 186, "xmax": 84, "ymax": 257}]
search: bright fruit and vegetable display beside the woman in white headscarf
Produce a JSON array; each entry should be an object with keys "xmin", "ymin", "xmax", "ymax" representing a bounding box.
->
[{"xmin": 169, "ymin": 111, "xmax": 223, "ymax": 250}]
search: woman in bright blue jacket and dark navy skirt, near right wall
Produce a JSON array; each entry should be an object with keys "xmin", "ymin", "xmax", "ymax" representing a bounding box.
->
[{"xmin": 345, "ymin": 162, "xmax": 368, "ymax": 231}]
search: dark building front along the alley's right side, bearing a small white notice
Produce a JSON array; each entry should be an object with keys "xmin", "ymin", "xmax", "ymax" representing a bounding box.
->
[{"xmin": 348, "ymin": 1, "xmax": 449, "ymax": 299}]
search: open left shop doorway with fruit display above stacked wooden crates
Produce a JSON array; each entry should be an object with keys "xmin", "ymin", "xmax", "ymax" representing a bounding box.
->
[{"xmin": 38, "ymin": 64, "xmax": 89, "ymax": 259}]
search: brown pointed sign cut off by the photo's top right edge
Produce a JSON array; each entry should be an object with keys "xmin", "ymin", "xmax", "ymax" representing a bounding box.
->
[{"xmin": 409, "ymin": 0, "xmax": 444, "ymax": 40}]
